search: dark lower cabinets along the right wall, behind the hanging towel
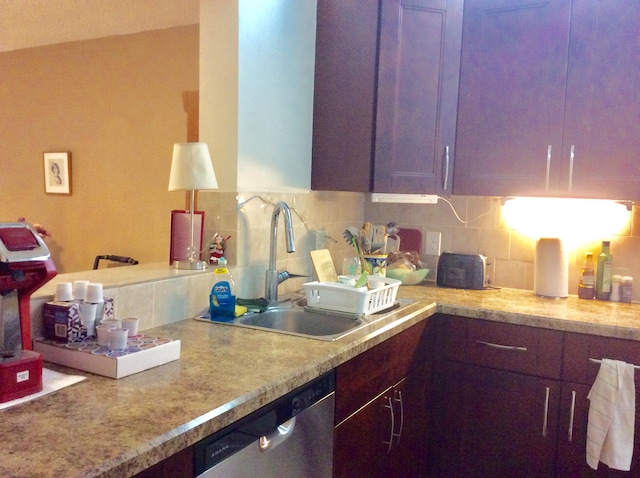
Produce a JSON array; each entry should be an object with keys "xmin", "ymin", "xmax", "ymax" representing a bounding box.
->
[{"xmin": 430, "ymin": 317, "xmax": 640, "ymax": 478}]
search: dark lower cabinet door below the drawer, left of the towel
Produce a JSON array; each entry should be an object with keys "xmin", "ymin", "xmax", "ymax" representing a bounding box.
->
[{"xmin": 432, "ymin": 362, "xmax": 560, "ymax": 478}]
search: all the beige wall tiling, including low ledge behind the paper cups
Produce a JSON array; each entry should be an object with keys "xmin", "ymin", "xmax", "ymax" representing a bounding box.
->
[{"xmin": 31, "ymin": 192, "xmax": 640, "ymax": 337}]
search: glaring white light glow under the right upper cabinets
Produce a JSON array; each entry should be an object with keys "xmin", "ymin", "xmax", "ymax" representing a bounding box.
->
[{"xmin": 502, "ymin": 197, "xmax": 631, "ymax": 246}]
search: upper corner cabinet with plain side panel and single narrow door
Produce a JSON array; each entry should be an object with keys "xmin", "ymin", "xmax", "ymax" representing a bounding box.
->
[{"xmin": 311, "ymin": 0, "xmax": 462, "ymax": 194}]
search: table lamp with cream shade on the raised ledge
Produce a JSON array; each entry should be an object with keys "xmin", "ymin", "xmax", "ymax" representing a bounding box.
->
[{"xmin": 169, "ymin": 143, "xmax": 218, "ymax": 270}]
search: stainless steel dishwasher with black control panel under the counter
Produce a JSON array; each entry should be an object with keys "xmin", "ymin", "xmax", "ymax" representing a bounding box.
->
[{"xmin": 194, "ymin": 372, "xmax": 335, "ymax": 478}]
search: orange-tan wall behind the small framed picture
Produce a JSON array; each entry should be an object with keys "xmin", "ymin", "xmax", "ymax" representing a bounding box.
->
[{"xmin": 0, "ymin": 25, "xmax": 199, "ymax": 272}]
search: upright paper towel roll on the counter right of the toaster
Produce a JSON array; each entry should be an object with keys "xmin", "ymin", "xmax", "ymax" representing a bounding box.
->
[{"xmin": 533, "ymin": 237, "xmax": 569, "ymax": 297}]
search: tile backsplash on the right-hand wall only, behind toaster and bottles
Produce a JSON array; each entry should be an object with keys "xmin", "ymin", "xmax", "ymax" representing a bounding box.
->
[{"xmin": 365, "ymin": 196, "xmax": 640, "ymax": 301}]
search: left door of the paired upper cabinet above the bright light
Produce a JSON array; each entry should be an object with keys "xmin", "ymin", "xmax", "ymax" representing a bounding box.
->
[{"xmin": 453, "ymin": 0, "xmax": 572, "ymax": 196}]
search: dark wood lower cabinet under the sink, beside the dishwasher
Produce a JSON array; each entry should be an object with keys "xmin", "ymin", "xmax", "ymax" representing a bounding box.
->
[{"xmin": 334, "ymin": 320, "xmax": 433, "ymax": 478}]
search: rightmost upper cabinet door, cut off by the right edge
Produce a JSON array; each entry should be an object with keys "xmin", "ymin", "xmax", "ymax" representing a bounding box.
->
[{"xmin": 562, "ymin": 0, "xmax": 640, "ymax": 200}]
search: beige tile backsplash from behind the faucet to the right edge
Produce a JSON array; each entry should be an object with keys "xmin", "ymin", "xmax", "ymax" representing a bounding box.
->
[{"xmin": 205, "ymin": 191, "xmax": 640, "ymax": 301}]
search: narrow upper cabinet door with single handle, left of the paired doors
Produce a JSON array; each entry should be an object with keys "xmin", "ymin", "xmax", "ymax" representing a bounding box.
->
[{"xmin": 373, "ymin": 0, "xmax": 462, "ymax": 194}]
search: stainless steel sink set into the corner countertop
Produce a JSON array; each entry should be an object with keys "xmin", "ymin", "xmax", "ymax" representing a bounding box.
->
[{"xmin": 198, "ymin": 299, "xmax": 414, "ymax": 341}]
